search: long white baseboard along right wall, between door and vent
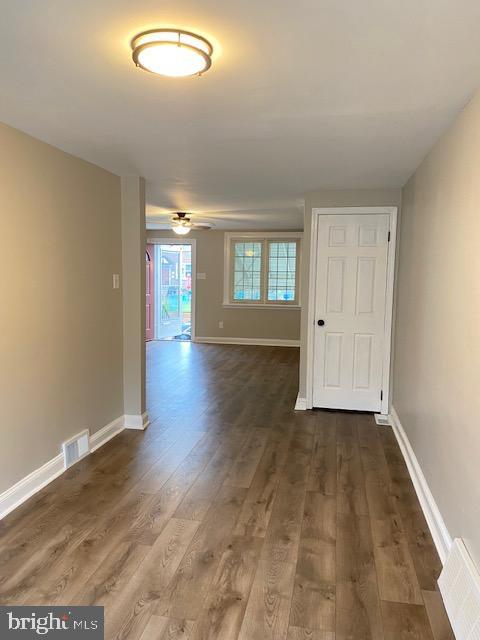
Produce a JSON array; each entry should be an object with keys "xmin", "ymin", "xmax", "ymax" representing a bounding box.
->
[{"xmin": 390, "ymin": 407, "xmax": 452, "ymax": 564}]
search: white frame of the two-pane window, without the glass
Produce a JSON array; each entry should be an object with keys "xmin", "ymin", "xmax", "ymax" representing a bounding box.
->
[{"xmin": 223, "ymin": 231, "xmax": 303, "ymax": 309}]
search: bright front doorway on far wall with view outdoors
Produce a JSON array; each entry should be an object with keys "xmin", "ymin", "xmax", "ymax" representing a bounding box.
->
[{"xmin": 146, "ymin": 244, "xmax": 192, "ymax": 340}]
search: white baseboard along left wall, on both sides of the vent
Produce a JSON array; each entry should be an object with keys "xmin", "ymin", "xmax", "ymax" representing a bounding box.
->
[{"xmin": 0, "ymin": 416, "xmax": 125, "ymax": 520}]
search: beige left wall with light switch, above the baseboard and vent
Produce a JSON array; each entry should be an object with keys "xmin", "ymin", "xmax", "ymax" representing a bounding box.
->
[{"xmin": 0, "ymin": 124, "xmax": 123, "ymax": 492}]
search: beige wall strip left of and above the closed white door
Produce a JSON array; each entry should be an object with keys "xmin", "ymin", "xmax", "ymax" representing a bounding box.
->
[{"xmin": 298, "ymin": 189, "xmax": 402, "ymax": 398}]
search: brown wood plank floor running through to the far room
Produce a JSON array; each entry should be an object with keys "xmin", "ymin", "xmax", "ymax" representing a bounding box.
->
[{"xmin": 0, "ymin": 342, "xmax": 453, "ymax": 640}]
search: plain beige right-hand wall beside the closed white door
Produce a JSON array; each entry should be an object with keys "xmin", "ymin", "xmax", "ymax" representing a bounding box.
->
[{"xmin": 393, "ymin": 94, "xmax": 480, "ymax": 564}]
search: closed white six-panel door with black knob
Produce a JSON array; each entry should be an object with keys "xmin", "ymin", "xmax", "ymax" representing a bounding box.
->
[{"xmin": 313, "ymin": 214, "xmax": 390, "ymax": 412}]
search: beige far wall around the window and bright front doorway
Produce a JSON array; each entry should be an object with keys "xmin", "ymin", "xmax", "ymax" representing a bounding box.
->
[{"xmin": 147, "ymin": 230, "xmax": 300, "ymax": 340}]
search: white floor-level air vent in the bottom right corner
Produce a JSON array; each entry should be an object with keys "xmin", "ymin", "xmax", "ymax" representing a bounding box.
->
[{"xmin": 438, "ymin": 538, "xmax": 480, "ymax": 640}]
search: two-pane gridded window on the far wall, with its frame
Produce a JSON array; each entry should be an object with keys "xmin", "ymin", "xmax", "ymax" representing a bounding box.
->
[{"xmin": 224, "ymin": 233, "xmax": 300, "ymax": 307}]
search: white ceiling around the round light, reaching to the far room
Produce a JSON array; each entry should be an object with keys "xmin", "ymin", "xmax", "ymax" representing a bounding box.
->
[{"xmin": 0, "ymin": 0, "xmax": 480, "ymax": 228}]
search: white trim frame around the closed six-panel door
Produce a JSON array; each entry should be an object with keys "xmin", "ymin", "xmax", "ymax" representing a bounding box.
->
[{"xmin": 306, "ymin": 207, "xmax": 398, "ymax": 414}]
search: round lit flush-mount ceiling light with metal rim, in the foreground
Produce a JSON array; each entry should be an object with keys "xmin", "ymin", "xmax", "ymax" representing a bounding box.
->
[{"xmin": 132, "ymin": 29, "xmax": 213, "ymax": 78}]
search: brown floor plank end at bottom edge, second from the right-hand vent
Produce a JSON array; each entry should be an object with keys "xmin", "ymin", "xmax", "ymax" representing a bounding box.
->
[{"xmin": 382, "ymin": 602, "xmax": 434, "ymax": 640}]
